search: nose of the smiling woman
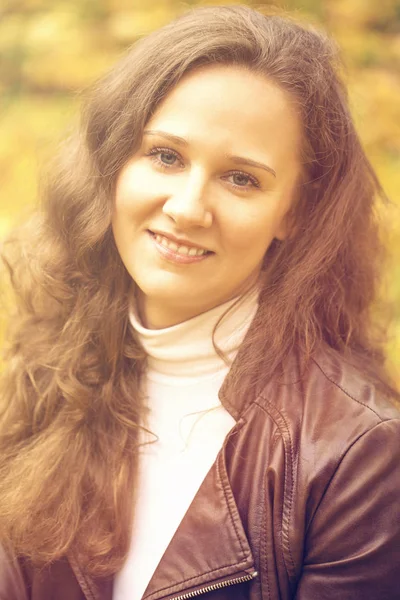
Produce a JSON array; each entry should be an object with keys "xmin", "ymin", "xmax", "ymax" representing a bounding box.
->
[{"xmin": 163, "ymin": 173, "xmax": 213, "ymax": 229}]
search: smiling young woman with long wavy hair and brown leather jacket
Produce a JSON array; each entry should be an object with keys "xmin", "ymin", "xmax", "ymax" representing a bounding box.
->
[{"xmin": 0, "ymin": 6, "xmax": 400, "ymax": 600}]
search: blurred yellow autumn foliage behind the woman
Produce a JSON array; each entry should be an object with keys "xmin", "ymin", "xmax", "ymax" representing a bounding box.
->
[{"xmin": 0, "ymin": 0, "xmax": 400, "ymax": 385}]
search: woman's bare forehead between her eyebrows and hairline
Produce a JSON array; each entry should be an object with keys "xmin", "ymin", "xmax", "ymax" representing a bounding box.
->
[{"xmin": 145, "ymin": 65, "xmax": 301, "ymax": 166}]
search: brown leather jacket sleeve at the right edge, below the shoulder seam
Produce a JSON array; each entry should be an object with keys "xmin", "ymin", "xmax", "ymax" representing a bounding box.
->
[{"xmin": 295, "ymin": 419, "xmax": 400, "ymax": 600}]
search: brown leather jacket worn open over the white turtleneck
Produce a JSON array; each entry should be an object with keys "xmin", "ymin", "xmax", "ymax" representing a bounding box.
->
[{"xmin": 0, "ymin": 352, "xmax": 400, "ymax": 600}]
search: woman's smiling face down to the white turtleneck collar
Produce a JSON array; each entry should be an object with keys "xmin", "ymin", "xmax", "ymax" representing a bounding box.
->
[{"xmin": 112, "ymin": 65, "xmax": 301, "ymax": 328}]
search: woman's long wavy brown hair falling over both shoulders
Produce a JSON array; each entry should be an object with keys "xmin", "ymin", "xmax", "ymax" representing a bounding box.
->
[{"xmin": 0, "ymin": 6, "xmax": 396, "ymax": 576}]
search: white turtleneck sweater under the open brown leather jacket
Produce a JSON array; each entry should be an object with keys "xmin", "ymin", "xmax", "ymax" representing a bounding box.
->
[{"xmin": 113, "ymin": 292, "xmax": 258, "ymax": 600}]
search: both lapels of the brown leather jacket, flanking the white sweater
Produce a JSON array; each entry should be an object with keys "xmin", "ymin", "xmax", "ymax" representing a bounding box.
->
[{"xmin": 70, "ymin": 436, "xmax": 255, "ymax": 600}]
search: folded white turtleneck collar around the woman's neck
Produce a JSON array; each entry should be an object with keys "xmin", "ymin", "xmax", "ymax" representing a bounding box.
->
[{"xmin": 129, "ymin": 290, "xmax": 259, "ymax": 378}]
